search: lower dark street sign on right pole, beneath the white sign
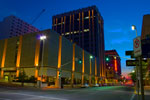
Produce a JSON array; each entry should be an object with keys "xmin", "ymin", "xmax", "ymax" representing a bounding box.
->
[{"xmin": 126, "ymin": 60, "xmax": 148, "ymax": 66}]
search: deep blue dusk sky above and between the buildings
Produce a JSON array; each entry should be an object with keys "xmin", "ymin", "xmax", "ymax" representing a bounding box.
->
[{"xmin": 0, "ymin": 0, "xmax": 150, "ymax": 76}]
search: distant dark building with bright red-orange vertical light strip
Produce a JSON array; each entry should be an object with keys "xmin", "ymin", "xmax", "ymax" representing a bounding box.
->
[{"xmin": 105, "ymin": 50, "xmax": 121, "ymax": 79}]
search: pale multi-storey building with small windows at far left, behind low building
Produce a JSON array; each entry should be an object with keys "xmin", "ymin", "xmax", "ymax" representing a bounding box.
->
[{"xmin": 0, "ymin": 15, "xmax": 39, "ymax": 39}]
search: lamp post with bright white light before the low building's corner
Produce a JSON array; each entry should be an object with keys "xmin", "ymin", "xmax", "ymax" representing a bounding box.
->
[{"xmin": 40, "ymin": 35, "xmax": 46, "ymax": 87}]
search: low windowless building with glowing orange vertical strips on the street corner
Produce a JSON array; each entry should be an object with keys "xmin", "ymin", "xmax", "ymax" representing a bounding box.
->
[{"xmin": 0, "ymin": 30, "xmax": 97, "ymax": 87}]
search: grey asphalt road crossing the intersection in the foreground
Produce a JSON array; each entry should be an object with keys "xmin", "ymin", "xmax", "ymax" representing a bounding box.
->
[{"xmin": 0, "ymin": 86, "xmax": 150, "ymax": 100}]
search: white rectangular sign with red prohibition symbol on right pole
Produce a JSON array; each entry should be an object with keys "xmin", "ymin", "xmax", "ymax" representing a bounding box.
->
[{"xmin": 133, "ymin": 36, "xmax": 142, "ymax": 57}]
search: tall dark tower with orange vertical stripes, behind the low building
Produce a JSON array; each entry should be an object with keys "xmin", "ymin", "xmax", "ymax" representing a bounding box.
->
[{"xmin": 52, "ymin": 6, "xmax": 105, "ymax": 77}]
